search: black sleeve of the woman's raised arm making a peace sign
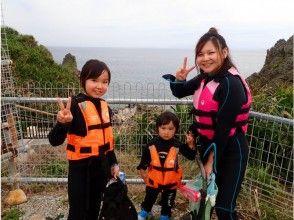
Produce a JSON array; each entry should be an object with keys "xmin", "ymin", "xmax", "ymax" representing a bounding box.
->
[{"xmin": 170, "ymin": 75, "xmax": 202, "ymax": 98}]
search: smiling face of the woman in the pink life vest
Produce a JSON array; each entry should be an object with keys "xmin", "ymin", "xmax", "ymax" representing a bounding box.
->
[{"xmin": 196, "ymin": 40, "xmax": 228, "ymax": 73}]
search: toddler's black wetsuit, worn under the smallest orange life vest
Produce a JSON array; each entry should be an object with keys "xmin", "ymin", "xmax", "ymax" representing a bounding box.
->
[{"xmin": 137, "ymin": 136, "xmax": 196, "ymax": 216}]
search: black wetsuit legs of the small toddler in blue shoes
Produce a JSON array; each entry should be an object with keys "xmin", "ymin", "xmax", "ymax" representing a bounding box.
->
[{"xmin": 141, "ymin": 186, "xmax": 177, "ymax": 216}]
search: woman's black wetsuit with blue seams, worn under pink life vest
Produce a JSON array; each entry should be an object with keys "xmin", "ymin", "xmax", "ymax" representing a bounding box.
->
[{"xmin": 170, "ymin": 67, "xmax": 249, "ymax": 220}]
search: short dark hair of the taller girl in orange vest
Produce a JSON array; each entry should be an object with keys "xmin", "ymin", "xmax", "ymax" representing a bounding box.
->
[{"xmin": 80, "ymin": 60, "xmax": 111, "ymax": 89}]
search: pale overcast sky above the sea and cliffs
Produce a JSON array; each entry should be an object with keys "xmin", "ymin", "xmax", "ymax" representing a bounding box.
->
[{"xmin": 2, "ymin": 0, "xmax": 294, "ymax": 50}]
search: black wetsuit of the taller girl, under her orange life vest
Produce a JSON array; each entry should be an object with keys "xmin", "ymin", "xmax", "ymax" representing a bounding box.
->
[{"xmin": 48, "ymin": 93, "xmax": 117, "ymax": 220}]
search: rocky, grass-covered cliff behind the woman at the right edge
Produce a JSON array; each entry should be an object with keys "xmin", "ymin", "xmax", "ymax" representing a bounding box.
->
[{"xmin": 247, "ymin": 35, "xmax": 294, "ymax": 114}]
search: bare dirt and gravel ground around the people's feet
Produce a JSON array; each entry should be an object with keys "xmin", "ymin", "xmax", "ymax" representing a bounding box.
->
[{"xmin": 1, "ymin": 184, "xmax": 223, "ymax": 220}]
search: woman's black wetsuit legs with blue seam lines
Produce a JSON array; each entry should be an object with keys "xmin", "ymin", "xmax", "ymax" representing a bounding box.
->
[{"xmin": 215, "ymin": 133, "xmax": 249, "ymax": 220}]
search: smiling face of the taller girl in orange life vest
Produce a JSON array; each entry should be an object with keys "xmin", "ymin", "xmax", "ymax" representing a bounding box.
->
[{"xmin": 85, "ymin": 70, "xmax": 109, "ymax": 98}]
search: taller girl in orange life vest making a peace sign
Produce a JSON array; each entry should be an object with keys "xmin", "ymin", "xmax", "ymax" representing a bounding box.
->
[{"xmin": 48, "ymin": 60, "xmax": 119, "ymax": 220}]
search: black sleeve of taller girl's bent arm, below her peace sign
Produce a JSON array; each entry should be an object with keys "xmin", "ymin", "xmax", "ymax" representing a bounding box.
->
[{"xmin": 48, "ymin": 122, "xmax": 70, "ymax": 146}]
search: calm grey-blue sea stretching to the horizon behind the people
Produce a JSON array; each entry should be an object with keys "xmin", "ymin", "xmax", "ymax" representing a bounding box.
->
[{"xmin": 48, "ymin": 47, "xmax": 266, "ymax": 82}]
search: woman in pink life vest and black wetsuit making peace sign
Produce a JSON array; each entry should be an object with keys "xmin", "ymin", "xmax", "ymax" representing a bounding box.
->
[{"xmin": 169, "ymin": 28, "xmax": 252, "ymax": 220}]
